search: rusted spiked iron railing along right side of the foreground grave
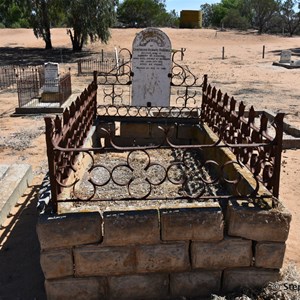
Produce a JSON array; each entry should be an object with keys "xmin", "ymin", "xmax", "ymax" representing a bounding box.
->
[{"xmin": 201, "ymin": 85, "xmax": 284, "ymax": 197}]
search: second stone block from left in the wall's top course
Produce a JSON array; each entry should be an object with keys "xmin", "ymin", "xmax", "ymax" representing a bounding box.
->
[{"xmin": 103, "ymin": 209, "xmax": 160, "ymax": 245}]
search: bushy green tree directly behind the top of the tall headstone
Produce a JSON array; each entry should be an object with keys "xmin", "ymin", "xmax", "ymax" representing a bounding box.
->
[{"xmin": 117, "ymin": 0, "xmax": 166, "ymax": 27}]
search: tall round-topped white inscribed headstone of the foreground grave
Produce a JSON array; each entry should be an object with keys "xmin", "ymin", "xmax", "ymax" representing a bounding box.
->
[{"xmin": 132, "ymin": 28, "xmax": 172, "ymax": 106}]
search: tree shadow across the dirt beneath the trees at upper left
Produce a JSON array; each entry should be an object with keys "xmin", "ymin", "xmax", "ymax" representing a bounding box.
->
[{"xmin": 0, "ymin": 47, "xmax": 94, "ymax": 66}]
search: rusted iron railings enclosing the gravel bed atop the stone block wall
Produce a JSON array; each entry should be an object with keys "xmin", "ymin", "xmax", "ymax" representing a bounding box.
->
[{"xmin": 45, "ymin": 77, "xmax": 283, "ymax": 211}]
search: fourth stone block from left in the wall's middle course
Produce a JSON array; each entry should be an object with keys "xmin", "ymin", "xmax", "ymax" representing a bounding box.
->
[{"xmin": 191, "ymin": 238, "xmax": 253, "ymax": 270}]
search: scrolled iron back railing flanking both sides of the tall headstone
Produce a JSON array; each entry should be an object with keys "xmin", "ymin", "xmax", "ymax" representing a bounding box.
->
[{"xmin": 91, "ymin": 48, "xmax": 204, "ymax": 107}]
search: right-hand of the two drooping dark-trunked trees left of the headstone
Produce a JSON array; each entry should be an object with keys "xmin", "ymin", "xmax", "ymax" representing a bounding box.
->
[{"xmin": 61, "ymin": 0, "xmax": 116, "ymax": 51}]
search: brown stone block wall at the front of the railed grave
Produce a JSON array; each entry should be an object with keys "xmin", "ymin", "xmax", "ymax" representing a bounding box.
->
[{"xmin": 37, "ymin": 201, "xmax": 291, "ymax": 300}]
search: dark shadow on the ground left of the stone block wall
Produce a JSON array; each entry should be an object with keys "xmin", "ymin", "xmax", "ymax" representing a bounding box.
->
[{"xmin": 0, "ymin": 186, "xmax": 46, "ymax": 300}]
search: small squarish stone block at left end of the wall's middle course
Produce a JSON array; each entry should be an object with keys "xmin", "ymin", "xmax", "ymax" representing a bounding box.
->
[{"xmin": 40, "ymin": 249, "xmax": 74, "ymax": 279}]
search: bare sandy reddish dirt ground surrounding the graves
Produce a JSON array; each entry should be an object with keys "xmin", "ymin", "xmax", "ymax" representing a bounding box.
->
[{"xmin": 0, "ymin": 29, "xmax": 300, "ymax": 300}]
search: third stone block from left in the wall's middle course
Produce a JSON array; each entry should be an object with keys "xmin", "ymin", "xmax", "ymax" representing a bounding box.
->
[{"xmin": 136, "ymin": 242, "xmax": 190, "ymax": 273}]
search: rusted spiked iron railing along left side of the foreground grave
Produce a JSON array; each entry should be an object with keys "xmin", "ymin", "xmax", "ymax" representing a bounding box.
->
[{"xmin": 45, "ymin": 83, "xmax": 97, "ymax": 207}]
